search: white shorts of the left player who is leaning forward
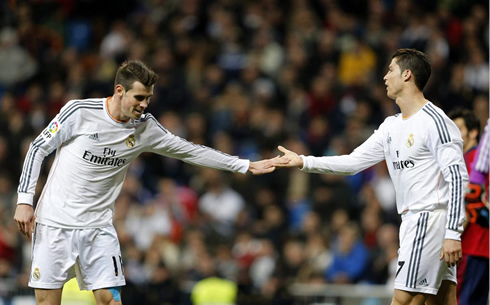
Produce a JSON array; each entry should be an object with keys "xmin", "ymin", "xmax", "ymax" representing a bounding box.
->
[{"xmin": 29, "ymin": 223, "xmax": 126, "ymax": 290}]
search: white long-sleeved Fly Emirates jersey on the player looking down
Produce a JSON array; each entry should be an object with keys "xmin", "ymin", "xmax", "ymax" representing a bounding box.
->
[{"xmin": 18, "ymin": 98, "xmax": 249, "ymax": 228}]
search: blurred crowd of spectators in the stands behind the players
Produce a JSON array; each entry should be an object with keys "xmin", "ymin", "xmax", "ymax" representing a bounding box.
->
[{"xmin": 0, "ymin": 0, "xmax": 489, "ymax": 304}]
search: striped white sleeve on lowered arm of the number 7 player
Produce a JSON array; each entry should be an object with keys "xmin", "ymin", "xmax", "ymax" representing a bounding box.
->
[{"xmin": 426, "ymin": 115, "xmax": 468, "ymax": 240}]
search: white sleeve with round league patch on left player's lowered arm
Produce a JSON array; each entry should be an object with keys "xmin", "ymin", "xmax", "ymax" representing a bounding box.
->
[{"xmin": 17, "ymin": 101, "xmax": 78, "ymax": 205}]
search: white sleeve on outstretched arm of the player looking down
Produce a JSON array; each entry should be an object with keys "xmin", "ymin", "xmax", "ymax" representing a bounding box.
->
[{"xmin": 142, "ymin": 114, "xmax": 250, "ymax": 174}]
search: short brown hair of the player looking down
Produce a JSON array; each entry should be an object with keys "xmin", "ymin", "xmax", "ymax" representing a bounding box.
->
[{"xmin": 114, "ymin": 60, "xmax": 158, "ymax": 90}]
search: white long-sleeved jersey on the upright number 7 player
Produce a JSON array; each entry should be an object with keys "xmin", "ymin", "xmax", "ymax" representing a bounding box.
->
[{"xmin": 301, "ymin": 102, "xmax": 468, "ymax": 240}]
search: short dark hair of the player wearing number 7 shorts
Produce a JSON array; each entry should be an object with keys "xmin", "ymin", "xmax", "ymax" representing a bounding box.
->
[{"xmin": 392, "ymin": 49, "xmax": 432, "ymax": 91}]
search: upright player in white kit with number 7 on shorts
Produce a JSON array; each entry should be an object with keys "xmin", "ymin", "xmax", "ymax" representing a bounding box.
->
[{"xmin": 277, "ymin": 49, "xmax": 468, "ymax": 305}]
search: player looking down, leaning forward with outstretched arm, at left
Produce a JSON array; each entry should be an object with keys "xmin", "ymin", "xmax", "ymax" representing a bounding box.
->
[{"xmin": 14, "ymin": 61, "xmax": 288, "ymax": 305}]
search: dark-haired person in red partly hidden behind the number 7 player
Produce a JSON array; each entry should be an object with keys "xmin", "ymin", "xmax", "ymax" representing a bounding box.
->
[{"xmin": 448, "ymin": 109, "xmax": 489, "ymax": 305}]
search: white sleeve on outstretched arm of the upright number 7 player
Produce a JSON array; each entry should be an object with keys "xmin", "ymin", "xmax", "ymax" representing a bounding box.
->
[{"xmin": 300, "ymin": 121, "xmax": 387, "ymax": 175}]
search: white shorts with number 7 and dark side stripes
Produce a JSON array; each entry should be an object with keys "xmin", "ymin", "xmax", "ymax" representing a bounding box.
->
[{"xmin": 395, "ymin": 209, "xmax": 456, "ymax": 295}]
